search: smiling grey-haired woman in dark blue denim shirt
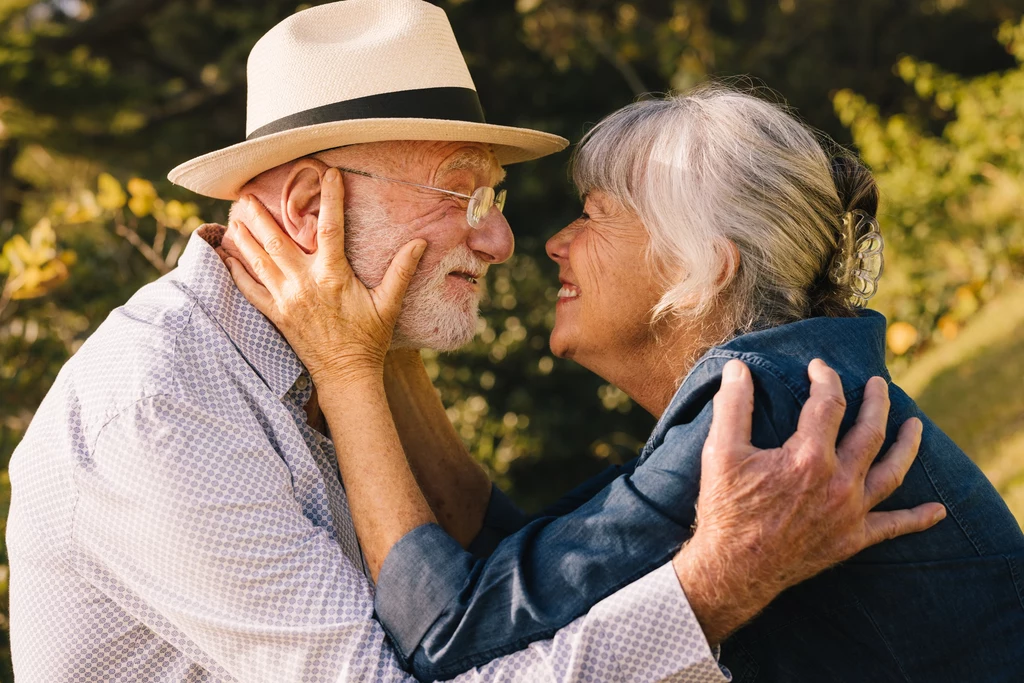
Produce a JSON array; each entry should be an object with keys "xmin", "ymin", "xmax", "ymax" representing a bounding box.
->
[{"xmin": 226, "ymin": 87, "xmax": 1024, "ymax": 683}]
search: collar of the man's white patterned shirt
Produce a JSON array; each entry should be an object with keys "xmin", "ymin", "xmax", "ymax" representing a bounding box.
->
[{"xmin": 173, "ymin": 223, "xmax": 305, "ymax": 398}]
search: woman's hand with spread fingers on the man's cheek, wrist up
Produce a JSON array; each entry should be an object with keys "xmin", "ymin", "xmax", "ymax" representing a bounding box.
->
[{"xmin": 226, "ymin": 169, "xmax": 426, "ymax": 389}]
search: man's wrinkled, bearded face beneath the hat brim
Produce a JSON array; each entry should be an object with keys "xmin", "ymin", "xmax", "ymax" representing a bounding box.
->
[{"xmin": 335, "ymin": 142, "xmax": 514, "ymax": 350}]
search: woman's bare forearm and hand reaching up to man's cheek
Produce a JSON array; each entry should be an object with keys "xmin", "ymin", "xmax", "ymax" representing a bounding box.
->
[{"xmin": 227, "ymin": 174, "xmax": 436, "ymax": 580}]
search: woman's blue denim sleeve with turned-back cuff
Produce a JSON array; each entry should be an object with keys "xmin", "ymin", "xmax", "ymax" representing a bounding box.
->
[{"xmin": 375, "ymin": 357, "xmax": 773, "ymax": 680}]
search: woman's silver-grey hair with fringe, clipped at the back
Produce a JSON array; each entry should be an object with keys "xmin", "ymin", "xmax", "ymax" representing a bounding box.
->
[{"xmin": 571, "ymin": 84, "xmax": 879, "ymax": 333}]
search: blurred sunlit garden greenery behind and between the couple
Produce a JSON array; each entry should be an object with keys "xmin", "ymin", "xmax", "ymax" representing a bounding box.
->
[{"xmin": 0, "ymin": 0, "xmax": 1024, "ymax": 680}]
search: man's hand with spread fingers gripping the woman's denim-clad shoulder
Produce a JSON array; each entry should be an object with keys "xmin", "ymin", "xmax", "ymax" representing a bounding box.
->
[{"xmin": 673, "ymin": 360, "xmax": 945, "ymax": 644}]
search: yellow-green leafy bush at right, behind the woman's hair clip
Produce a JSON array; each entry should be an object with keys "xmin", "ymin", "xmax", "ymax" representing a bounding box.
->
[{"xmin": 834, "ymin": 17, "xmax": 1024, "ymax": 368}]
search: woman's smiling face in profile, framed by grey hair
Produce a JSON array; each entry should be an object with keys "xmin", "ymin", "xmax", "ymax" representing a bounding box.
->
[{"xmin": 547, "ymin": 190, "xmax": 662, "ymax": 377}]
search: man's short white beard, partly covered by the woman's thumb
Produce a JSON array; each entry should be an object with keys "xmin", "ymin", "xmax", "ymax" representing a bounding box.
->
[{"xmin": 345, "ymin": 202, "xmax": 487, "ymax": 351}]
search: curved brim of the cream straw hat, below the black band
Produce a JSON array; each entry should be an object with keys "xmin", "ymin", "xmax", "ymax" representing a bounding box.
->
[{"xmin": 167, "ymin": 119, "xmax": 568, "ymax": 200}]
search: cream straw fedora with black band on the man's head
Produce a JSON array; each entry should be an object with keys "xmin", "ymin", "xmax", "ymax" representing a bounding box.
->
[{"xmin": 167, "ymin": 0, "xmax": 568, "ymax": 200}]
